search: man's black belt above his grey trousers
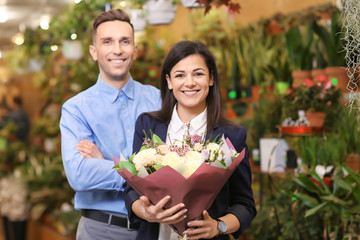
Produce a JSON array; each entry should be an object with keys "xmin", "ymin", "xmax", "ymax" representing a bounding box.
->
[{"xmin": 81, "ymin": 209, "xmax": 139, "ymax": 231}]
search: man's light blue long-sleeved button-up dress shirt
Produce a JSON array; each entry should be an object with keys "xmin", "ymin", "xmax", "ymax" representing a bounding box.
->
[{"xmin": 60, "ymin": 76, "xmax": 161, "ymax": 214}]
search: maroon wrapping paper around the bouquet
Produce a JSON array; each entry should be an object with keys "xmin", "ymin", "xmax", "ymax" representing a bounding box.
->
[{"xmin": 114, "ymin": 149, "xmax": 245, "ymax": 235}]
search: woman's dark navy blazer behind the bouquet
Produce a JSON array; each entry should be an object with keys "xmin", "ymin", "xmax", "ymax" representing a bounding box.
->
[{"xmin": 125, "ymin": 114, "xmax": 256, "ymax": 240}]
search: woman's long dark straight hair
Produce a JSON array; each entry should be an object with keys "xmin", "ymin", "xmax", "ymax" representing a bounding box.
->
[{"xmin": 149, "ymin": 41, "xmax": 229, "ymax": 132}]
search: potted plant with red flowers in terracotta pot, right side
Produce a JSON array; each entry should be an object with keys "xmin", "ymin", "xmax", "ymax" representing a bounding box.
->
[{"xmin": 282, "ymin": 76, "xmax": 342, "ymax": 127}]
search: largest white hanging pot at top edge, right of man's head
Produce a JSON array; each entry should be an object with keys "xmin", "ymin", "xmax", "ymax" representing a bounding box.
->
[{"xmin": 144, "ymin": 0, "xmax": 176, "ymax": 25}]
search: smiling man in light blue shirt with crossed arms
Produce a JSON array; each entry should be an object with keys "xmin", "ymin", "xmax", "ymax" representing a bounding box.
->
[{"xmin": 60, "ymin": 9, "xmax": 161, "ymax": 240}]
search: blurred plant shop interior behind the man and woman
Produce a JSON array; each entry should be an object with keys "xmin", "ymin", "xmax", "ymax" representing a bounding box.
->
[{"xmin": 0, "ymin": 0, "xmax": 360, "ymax": 240}]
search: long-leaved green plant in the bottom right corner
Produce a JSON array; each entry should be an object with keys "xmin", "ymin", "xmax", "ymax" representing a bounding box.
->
[{"xmin": 293, "ymin": 167, "xmax": 360, "ymax": 239}]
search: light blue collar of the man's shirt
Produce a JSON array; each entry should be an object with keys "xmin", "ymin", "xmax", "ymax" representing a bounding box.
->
[{"xmin": 95, "ymin": 74, "xmax": 135, "ymax": 102}]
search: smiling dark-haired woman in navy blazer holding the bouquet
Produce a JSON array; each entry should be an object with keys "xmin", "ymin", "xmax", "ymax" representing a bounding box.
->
[{"xmin": 125, "ymin": 41, "xmax": 256, "ymax": 240}]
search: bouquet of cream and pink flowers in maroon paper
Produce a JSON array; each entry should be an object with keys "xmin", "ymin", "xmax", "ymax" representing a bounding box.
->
[{"xmin": 114, "ymin": 131, "xmax": 245, "ymax": 235}]
